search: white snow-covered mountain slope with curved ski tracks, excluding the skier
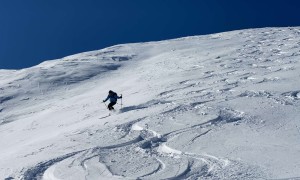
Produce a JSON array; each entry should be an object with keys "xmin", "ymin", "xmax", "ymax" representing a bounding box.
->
[{"xmin": 0, "ymin": 28, "xmax": 300, "ymax": 180}]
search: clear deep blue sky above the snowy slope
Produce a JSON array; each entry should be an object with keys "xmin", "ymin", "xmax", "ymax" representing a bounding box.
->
[{"xmin": 0, "ymin": 0, "xmax": 300, "ymax": 69}]
